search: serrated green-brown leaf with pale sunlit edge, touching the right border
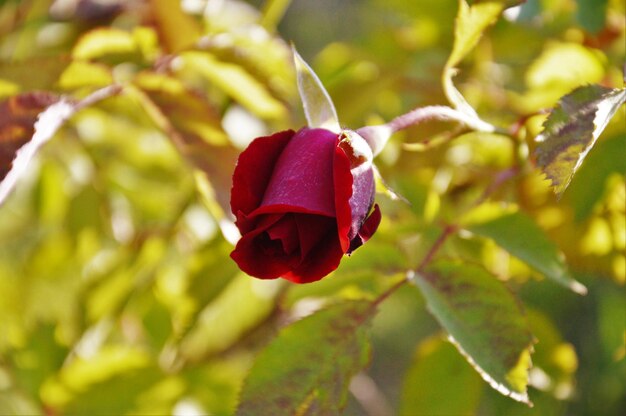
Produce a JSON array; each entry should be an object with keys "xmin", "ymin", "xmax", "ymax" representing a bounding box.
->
[{"xmin": 535, "ymin": 85, "xmax": 626, "ymax": 197}]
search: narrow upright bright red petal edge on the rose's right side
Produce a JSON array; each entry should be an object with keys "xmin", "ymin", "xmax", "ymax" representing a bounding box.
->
[{"xmin": 333, "ymin": 147, "xmax": 352, "ymax": 253}]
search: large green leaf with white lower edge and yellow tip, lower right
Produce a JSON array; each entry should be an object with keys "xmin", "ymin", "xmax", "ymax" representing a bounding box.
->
[{"xmin": 415, "ymin": 260, "xmax": 533, "ymax": 404}]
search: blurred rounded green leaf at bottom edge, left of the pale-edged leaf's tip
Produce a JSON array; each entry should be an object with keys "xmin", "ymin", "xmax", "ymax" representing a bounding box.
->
[{"xmin": 399, "ymin": 336, "xmax": 482, "ymax": 416}]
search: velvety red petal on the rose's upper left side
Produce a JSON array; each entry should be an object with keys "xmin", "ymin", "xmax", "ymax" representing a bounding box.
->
[{"xmin": 230, "ymin": 130, "xmax": 295, "ymax": 228}]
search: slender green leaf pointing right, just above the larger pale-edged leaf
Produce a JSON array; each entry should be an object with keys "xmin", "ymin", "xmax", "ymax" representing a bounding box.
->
[{"xmin": 468, "ymin": 212, "xmax": 587, "ymax": 295}]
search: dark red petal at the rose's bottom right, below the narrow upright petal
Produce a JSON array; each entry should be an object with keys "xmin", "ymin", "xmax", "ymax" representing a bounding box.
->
[{"xmin": 283, "ymin": 227, "xmax": 344, "ymax": 283}]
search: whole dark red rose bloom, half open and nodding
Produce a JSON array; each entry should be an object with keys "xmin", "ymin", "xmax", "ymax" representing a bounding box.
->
[{"xmin": 230, "ymin": 128, "xmax": 380, "ymax": 283}]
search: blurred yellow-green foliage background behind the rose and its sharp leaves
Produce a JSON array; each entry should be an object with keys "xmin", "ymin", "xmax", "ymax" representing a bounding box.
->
[{"xmin": 0, "ymin": 0, "xmax": 626, "ymax": 416}]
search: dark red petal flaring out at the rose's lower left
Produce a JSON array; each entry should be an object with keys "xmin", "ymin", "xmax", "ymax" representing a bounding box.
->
[{"xmin": 230, "ymin": 215, "xmax": 299, "ymax": 279}]
